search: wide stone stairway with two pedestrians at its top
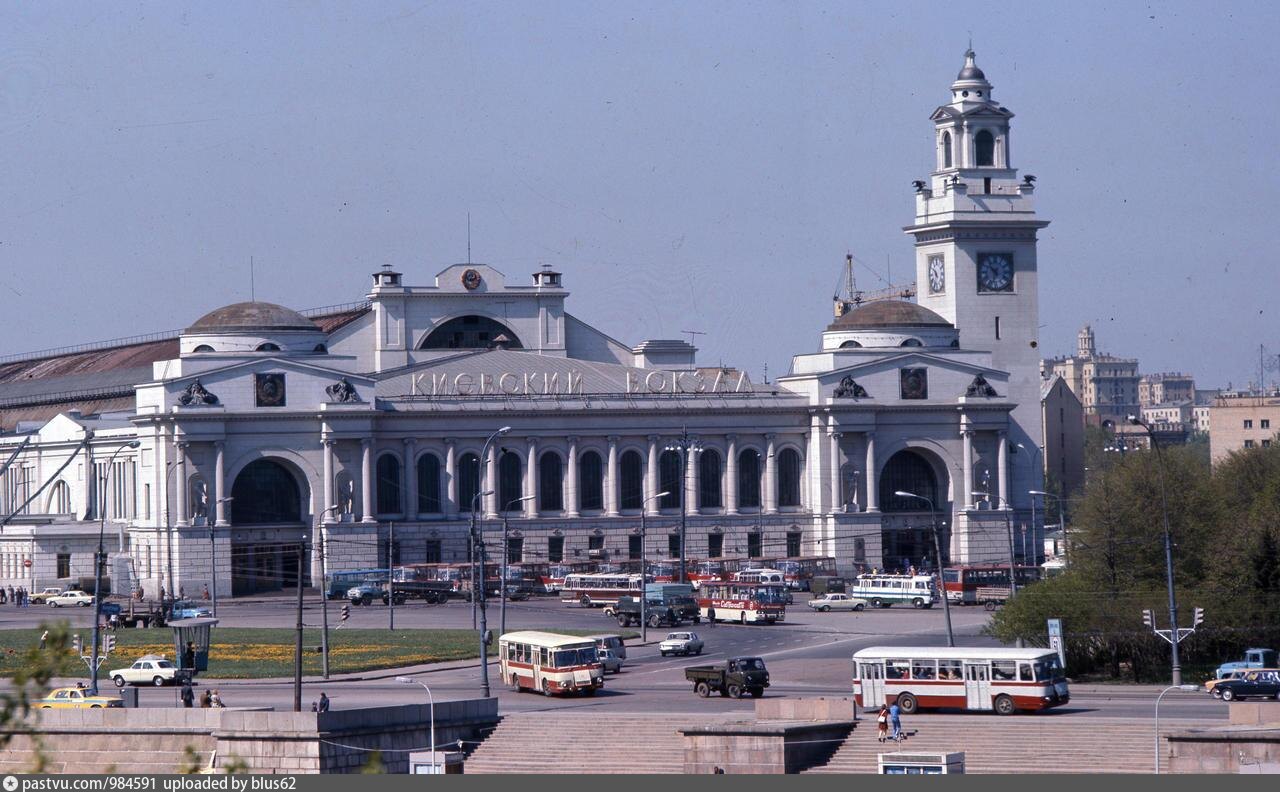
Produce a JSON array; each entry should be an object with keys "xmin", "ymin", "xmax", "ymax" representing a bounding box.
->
[{"xmin": 808, "ymin": 714, "xmax": 1203, "ymax": 774}]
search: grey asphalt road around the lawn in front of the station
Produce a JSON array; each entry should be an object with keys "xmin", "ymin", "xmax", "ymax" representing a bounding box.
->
[{"xmin": 10, "ymin": 595, "xmax": 1228, "ymax": 720}]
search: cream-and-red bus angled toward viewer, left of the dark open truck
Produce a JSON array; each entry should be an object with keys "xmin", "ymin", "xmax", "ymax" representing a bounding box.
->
[{"xmin": 498, "ymin": 630, "xmax": 604, "ymax": 696}]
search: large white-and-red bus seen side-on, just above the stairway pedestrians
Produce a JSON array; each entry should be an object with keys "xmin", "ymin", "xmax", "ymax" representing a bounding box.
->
[{"xmin": 854, "ymin": 646, "xmax": 1071, "ymax": 715}]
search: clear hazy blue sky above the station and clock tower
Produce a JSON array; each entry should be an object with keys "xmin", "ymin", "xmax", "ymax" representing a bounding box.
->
[{"xmin": 0, "ymin": 1, "xmax": 1280, "ymax": 385}]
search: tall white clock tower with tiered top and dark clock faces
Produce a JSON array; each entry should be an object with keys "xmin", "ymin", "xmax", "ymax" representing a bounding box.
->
[{"xmin": 904, "ymin": 50, "xmax": 1048, "ymax": 507}]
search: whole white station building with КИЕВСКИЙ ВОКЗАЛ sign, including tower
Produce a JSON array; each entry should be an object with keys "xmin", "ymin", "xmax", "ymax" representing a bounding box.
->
[{"xmin": 0, "ymin": 52, "xmax": 1047, "ymax": 596}]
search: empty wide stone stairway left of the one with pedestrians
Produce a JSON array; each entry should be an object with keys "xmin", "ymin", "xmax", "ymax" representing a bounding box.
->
[{"xmin": 465, "ymin": 709, "xmax": 726, "ymax": 774}]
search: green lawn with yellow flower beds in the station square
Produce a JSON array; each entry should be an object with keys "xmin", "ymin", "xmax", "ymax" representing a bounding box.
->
[{"xmin": 0, "ymin": 627, "xmax": 636, "ymax": 679}]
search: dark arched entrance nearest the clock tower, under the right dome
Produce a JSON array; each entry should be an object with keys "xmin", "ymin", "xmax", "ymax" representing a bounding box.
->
[{"xmin": 879, "ymin": 448, "xmax": 951, "ymax": 571}]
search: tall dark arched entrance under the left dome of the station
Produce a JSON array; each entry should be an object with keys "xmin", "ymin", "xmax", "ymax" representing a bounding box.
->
[{"xmin": 232, "ymin": 459, "xmax": 310, "ymax": 596}]
